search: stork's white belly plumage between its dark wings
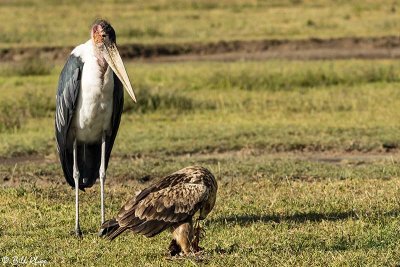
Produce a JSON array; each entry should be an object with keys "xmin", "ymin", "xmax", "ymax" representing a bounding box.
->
[{"xmin": 71, "ymin": 61, "xmax": 114, "ymax": 143}]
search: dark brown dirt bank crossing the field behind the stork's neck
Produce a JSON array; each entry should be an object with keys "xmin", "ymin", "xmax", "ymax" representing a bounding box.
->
[{"xmin": 0, "ymin": 36, "xmax": 400, "ymax": 62}]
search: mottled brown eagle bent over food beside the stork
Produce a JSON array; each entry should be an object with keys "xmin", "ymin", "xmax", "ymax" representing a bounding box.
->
[{"xmin": 100, "ymin": 166, "xmax": 217, "ymax": 254}]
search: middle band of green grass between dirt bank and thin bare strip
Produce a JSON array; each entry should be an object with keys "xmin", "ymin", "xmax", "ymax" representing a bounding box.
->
[{"xmin": 0, "ymin": 60, "xmax": 400, "ymax": 157}]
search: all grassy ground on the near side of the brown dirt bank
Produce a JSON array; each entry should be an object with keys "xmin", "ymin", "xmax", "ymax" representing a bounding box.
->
[{"xmin": 0, "ymin": 60, "xmax": 400, "ymax": 266}]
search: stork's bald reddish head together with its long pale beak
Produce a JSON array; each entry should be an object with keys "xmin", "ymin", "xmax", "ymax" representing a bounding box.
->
[{"xmin": 91, "ymin": 19, "xmax": 136, "ymax": 102}]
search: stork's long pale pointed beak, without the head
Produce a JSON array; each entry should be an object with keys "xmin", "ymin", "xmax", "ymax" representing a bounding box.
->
[{"xmin": 104, "ymin": 44, "xmax": 136, "ymax": 102}]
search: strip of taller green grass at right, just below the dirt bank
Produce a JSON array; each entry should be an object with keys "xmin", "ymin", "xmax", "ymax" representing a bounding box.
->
[{"xmin": 207, "ymin": 65, "xmax": 400, "ymax": 91}]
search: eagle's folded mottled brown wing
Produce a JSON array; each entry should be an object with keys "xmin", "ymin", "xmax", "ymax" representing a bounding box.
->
[{"xmin": 116, "ymin": 183, "xmax": 209, "ymax": 237}]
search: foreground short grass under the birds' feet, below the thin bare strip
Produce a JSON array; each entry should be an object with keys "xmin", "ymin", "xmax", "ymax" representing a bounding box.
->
[{"xmin": 0, "ymin": 154, "xmax": 400, "ymax": 266}]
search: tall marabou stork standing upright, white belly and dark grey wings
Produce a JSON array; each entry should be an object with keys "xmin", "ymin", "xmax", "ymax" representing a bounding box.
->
[{"xmin": 55, "ymin": 19, "xmax": 136, "ymax": 236}]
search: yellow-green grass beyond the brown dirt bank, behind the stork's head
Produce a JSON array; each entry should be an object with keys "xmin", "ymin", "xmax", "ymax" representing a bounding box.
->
[{"xmin": 0, "ymin": 0, "xmax": 400, "ymax": 48}]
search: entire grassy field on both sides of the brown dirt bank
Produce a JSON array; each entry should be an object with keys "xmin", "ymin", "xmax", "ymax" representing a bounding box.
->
[{"xmin": 0, "ymin": 0, "xmax": 400, "ymax": 266}]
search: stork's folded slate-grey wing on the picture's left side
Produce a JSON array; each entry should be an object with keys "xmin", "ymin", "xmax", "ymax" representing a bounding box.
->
[{"xmin": 55, "ymin": 55, "xmax": 83, "ymax": 186}]
